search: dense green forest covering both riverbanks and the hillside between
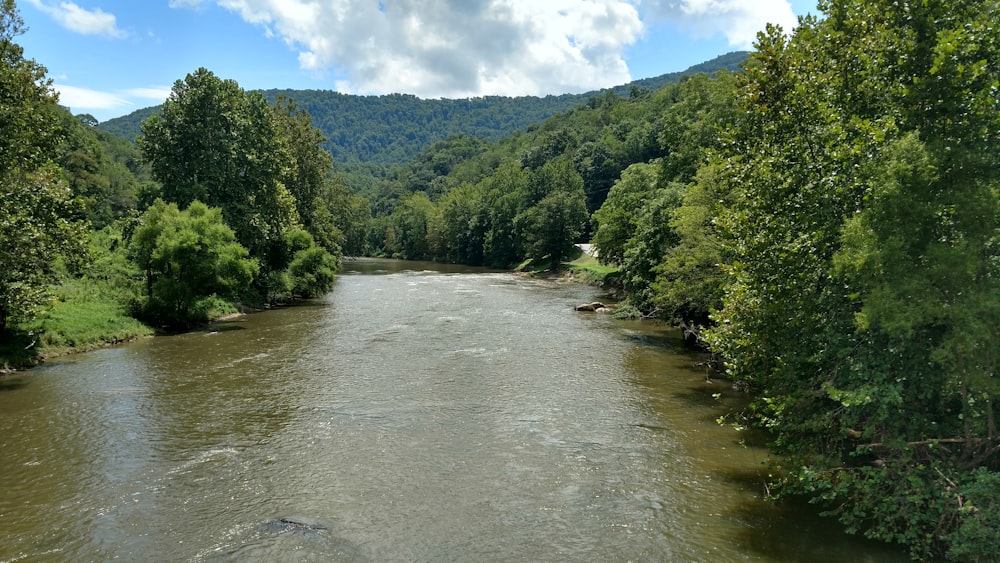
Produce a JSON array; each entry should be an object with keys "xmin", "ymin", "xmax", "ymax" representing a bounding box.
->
[{"xmin": 0, "ymin": 0, "xmax": 1000, "ymax": 561}]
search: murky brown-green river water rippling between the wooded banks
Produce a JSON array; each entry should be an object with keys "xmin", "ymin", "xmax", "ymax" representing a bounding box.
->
[{"xmin": 0, "ymin": 261, "xmax": 905, "ymax": 562}]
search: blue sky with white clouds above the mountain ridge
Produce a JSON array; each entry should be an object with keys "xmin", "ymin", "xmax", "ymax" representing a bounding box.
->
[{"xmin": 15, "ymin": 0, "xmax": 816, "ymax": 121}]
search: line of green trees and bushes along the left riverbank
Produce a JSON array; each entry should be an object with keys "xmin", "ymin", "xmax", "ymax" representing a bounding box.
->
[{"xmin": 0, "ymin": 0, "xmax": 367, "ymax": 347}]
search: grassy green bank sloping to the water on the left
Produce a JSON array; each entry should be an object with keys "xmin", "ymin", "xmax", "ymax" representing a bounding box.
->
[{"xmin": 0, "ymin": 279, "xmax": 153, "ymax": 370}]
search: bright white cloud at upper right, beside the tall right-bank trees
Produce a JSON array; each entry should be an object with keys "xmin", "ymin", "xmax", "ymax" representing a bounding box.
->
[{"xmin": 641, "ymin": 0, "xmax": 798, "ymax": 49}]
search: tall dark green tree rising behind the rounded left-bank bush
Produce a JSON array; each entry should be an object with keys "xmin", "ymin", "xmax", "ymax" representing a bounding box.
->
[{"xmin": 139, "ymin": 68, "xmax": 298, "ymax": 270}]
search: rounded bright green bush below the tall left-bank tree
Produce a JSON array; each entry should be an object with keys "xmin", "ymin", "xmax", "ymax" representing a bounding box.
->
[{"xmin": 129, "ymin": 200, "xmax": 258, "ymax": 326}]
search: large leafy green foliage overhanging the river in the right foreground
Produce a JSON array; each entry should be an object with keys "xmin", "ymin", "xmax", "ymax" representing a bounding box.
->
[{"xmin": 709, "ymin": 0, "xmax": 1000, "ymax": 558}]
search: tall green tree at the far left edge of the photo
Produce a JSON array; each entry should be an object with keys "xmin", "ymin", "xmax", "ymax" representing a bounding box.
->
[{"xmin": 0, "ymin": 0, "xmax": 86, "ymax": 332}]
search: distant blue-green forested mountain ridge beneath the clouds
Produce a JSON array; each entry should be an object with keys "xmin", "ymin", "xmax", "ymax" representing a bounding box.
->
[{"xmin": 98, "ymin": 51, "xmax": 749, "ymax": 165}]
